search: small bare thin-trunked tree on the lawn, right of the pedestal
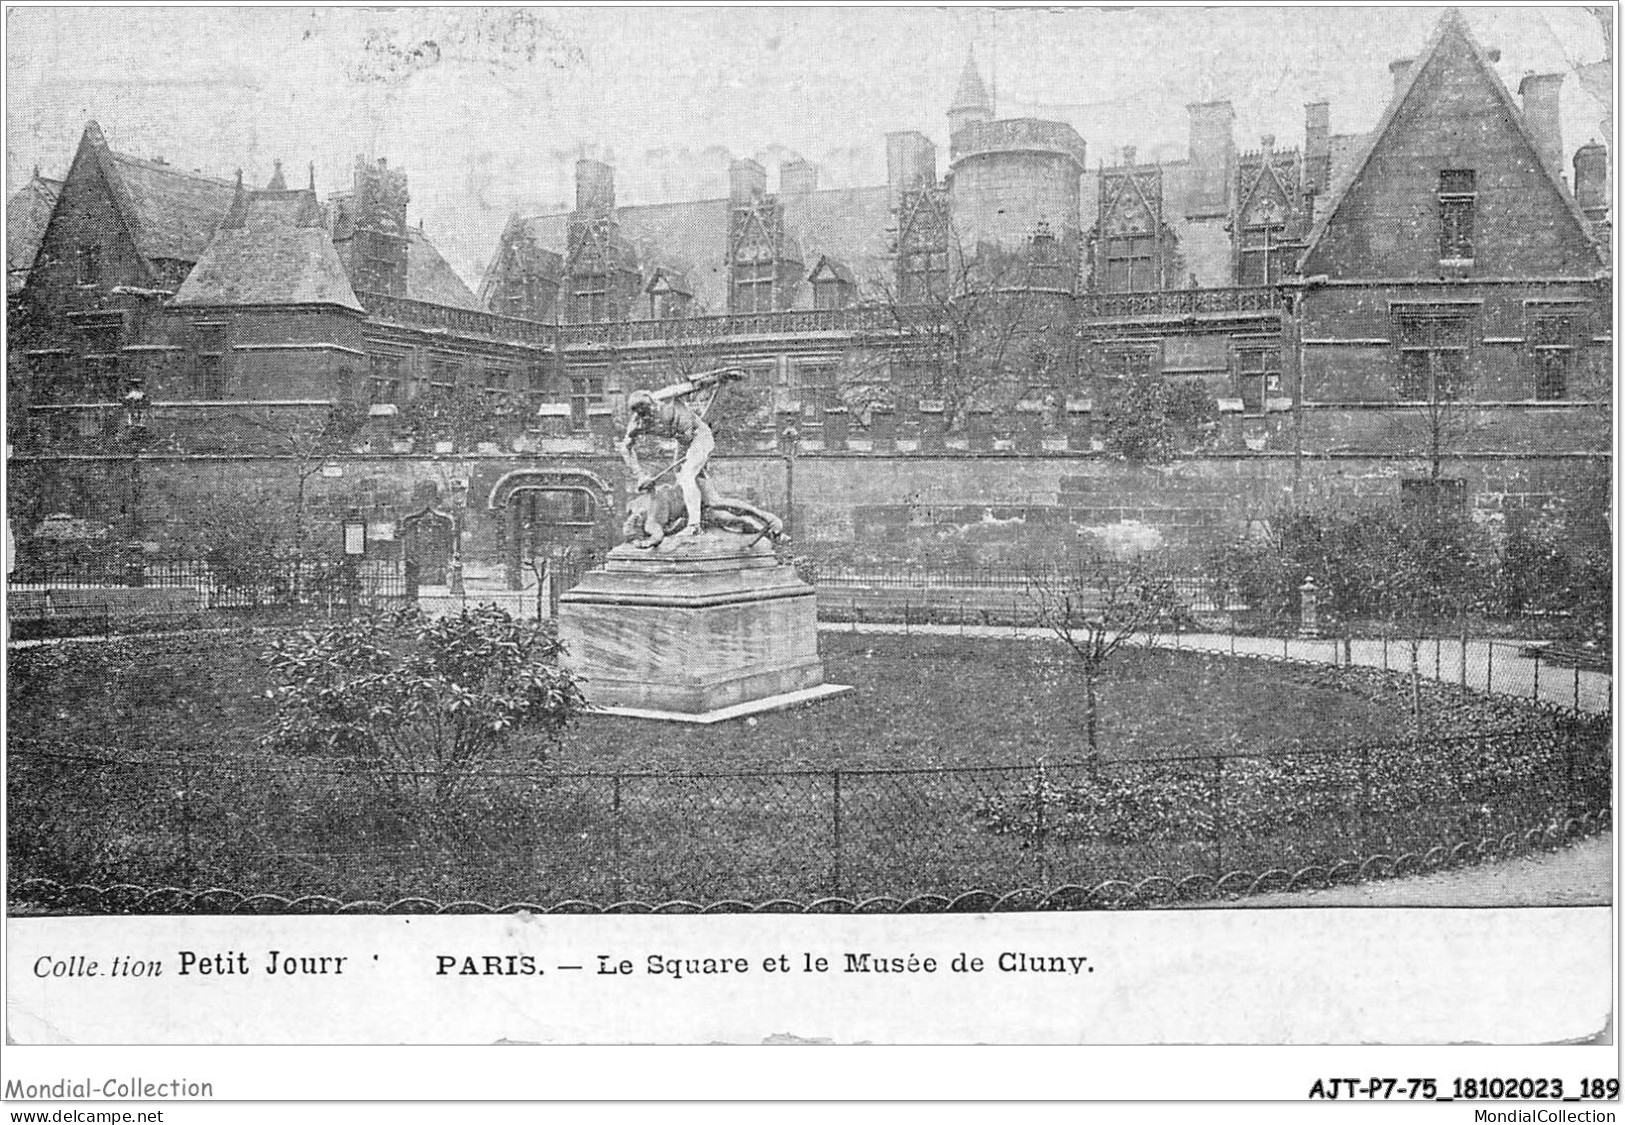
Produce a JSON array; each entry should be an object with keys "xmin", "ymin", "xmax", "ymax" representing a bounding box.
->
[{"xmin": 1029, "ymin": 554, "xmax": 1177, "ymax": 756}]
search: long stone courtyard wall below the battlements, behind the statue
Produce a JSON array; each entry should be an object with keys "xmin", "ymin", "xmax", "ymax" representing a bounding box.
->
[{"xmin": 8, "ymin": 450, "xmax": 1610, "ymax": 574}]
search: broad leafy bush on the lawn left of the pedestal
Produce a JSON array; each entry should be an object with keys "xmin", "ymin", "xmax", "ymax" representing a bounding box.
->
[{"xmin": 267, "ymin": 606, "xmax": 587, "ymax": 814}]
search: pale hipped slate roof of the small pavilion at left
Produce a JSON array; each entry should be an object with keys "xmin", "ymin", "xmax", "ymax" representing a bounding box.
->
[{"xmin": 172, "ymin": 190, "xmax": 362, "ymax": 312}]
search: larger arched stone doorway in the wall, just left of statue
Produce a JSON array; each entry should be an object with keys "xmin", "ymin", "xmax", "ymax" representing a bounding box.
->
[{"xmin": 486, "ymin": 470, "xmax": 614, "ymax": 590}]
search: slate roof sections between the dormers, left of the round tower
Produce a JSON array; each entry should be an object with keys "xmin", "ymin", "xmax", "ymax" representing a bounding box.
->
[{"xmin": 481, "ymin": 185, "xmax": 891, "ymax": 314}]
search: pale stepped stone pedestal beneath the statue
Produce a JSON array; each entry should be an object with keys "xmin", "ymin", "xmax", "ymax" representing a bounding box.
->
[{"xmin": 559, "ymin": 530, "xmax": 845, "ymax": 722}]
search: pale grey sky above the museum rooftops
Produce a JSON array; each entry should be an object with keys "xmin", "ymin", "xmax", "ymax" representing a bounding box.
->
[{"xmin": 5, "ymin": 5, "xmax": 1606, "ymax": 286}]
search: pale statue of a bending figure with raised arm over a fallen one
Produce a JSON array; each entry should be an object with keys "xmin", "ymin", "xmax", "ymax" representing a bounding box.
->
[{"xmin": 618, "ymin": 367, "xmax": 785, "ymax": 549}]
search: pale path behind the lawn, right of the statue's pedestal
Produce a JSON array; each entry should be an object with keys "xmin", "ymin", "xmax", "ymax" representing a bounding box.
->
[{"xmin": 819, "ymin": 621, "xmax": 1614, "ymax": 714}]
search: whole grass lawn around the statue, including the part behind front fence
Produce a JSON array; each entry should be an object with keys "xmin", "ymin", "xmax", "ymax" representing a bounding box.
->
[{"xmin": 8, "ymin": 632, "xmax": 1606, "ymax": 904}]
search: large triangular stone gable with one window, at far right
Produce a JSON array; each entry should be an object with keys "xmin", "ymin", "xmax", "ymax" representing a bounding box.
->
[{"xmin": 1300, "ymin": 10, "xmax": 1602, "ymax": 278}]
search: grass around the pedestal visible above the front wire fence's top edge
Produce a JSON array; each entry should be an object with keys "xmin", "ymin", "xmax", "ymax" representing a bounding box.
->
[{"xmin": 8, "ymin": 632, "xmax": 1406, "ymax": 771}]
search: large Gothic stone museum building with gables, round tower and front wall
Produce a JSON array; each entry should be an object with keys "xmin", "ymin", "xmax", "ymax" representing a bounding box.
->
[{"xmin": 10, "ymin": 11, "xmax": 1612, "ymax": 574}]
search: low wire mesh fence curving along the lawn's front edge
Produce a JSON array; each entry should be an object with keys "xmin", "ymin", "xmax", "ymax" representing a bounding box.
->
[{"xmin": 8, "ymin": 720, "xmax": 1612, "ymax": 909}]
